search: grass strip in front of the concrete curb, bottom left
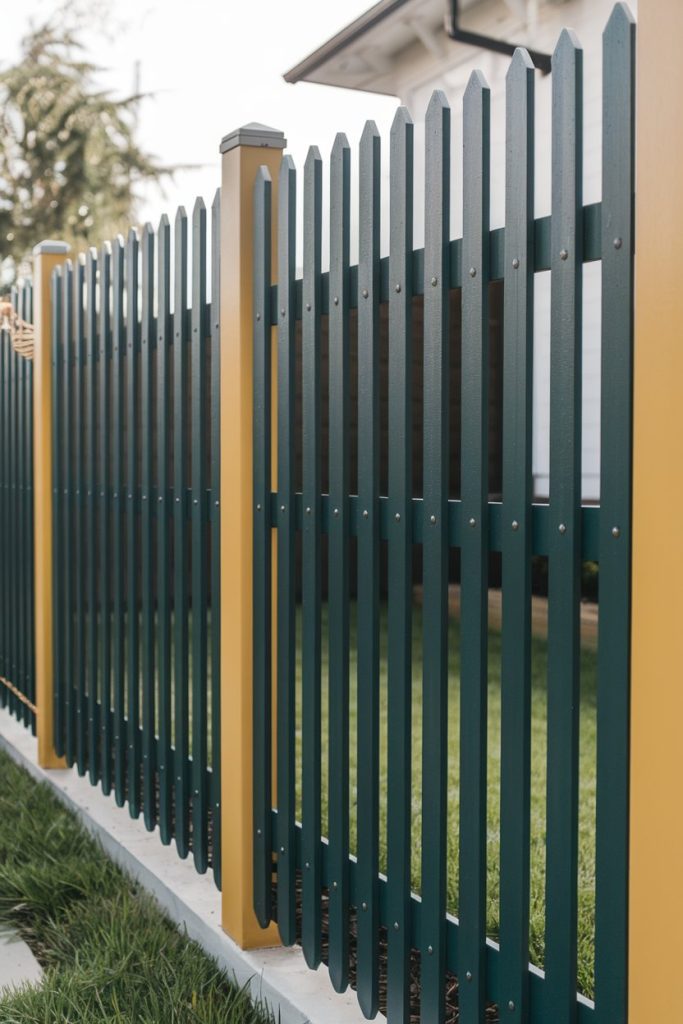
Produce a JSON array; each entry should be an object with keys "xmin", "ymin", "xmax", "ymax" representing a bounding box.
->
[{"xmin": 0, "ymin": 753, "xmax": 269, "ymax": 1024}]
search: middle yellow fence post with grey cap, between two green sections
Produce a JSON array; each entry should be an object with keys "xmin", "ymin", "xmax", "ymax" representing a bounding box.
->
[{"xmin": 220, "ymin": 124, "xmax": 286, "ymax": 949}]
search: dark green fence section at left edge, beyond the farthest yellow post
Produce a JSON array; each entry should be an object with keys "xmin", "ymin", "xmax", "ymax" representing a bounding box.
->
[{"xmin": 0, "ymin": 283, "xmax": 36, "ymax": 733}]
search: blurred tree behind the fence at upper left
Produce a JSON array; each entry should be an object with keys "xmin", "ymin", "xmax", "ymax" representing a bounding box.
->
[{"xmin": 0, "ymin": 3, "xmax": 171, "ymax": 285}]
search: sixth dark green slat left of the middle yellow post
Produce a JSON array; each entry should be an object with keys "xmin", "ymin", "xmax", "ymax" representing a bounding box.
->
[{"xmin": 125, "ymin": 228, "xmax": 140, "ymax": 818}]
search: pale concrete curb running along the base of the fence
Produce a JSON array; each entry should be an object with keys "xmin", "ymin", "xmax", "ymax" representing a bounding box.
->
[{"xmin": 0, "ymin": 709, "xmax": 376, "ymax": 1024}]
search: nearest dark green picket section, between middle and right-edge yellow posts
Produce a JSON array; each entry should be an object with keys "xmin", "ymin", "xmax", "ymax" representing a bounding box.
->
[{"xmin": 253, "ymin": 4, "xmax": 635, "ymax": 1024}]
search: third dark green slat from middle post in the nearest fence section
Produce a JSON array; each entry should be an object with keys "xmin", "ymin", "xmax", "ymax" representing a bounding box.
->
[{"xmin": 301, "ymin": 146, "xmax": 323, "ymax": 970}]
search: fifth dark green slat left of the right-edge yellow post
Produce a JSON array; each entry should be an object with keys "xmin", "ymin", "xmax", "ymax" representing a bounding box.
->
[{"xmin": 420, "ymin": 92, "xmax": 451, "ymax": 1024}]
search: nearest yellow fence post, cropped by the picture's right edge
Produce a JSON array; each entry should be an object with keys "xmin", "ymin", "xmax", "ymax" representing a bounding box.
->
[{"xmin": 629, "ymin": 0, "xmax": 683, "ymax": 1024}]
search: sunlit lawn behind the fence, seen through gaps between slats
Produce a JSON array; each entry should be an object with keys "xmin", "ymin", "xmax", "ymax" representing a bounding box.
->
[{"xmin": 297, "ymin": 606, "xmax": 596, "ymax": 996}]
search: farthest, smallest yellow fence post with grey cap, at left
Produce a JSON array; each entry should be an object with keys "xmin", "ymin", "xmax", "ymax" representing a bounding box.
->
[{"xmin": 33, "ymin": 242, "xmax": 69, "ymax": 768}]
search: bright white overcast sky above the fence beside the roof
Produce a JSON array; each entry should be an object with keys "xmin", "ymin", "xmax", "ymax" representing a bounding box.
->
[{"xmin": 0, "ymin": 0, "xmax": 395, "ymax": 228}]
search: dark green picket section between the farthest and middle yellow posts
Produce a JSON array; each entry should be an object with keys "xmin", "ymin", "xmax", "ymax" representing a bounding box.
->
[{"xmin": 52, "ymin": 201, "xmax": 220, "ymax": 886}]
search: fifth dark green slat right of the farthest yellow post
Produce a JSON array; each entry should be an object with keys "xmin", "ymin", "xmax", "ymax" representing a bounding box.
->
[{"xmin": 95, "ymin": 242, "xmax": 113, "ymax": 794}]
